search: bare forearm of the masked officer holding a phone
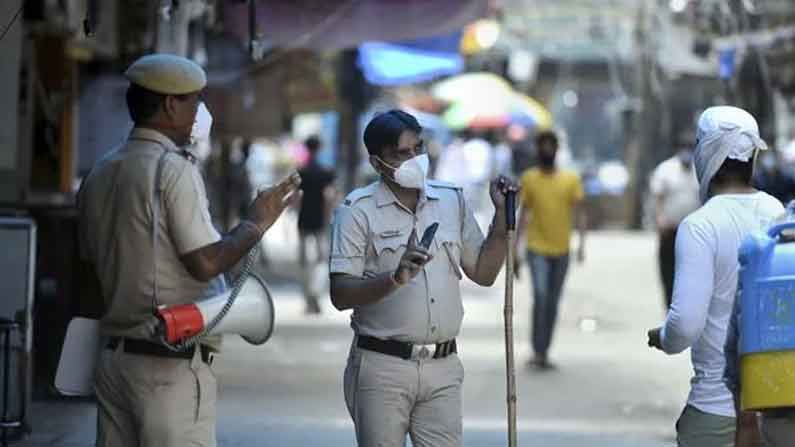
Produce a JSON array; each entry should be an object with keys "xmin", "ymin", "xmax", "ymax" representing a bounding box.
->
[{"xmin": 330, "ymin": 272, "xmax": 400, "ymax": 310}]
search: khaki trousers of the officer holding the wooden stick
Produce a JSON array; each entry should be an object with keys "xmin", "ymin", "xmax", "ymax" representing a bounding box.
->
[{"xmin": 344, "ymin": 341, "xmax": 464, "ymax": 447}]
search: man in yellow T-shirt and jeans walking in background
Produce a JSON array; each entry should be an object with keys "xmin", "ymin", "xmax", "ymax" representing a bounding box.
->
[{"xmin": 516, "ymin": 131, "xmax": 586, "ymax": 369}]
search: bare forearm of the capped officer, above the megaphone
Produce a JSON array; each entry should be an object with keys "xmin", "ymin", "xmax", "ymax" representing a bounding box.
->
[{"xmin": 181, "ymin": 220, "xmax": 263, "ymax": 281}]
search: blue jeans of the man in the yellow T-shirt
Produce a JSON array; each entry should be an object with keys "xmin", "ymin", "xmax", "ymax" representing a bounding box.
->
[{"xmin": 527, "ymin": 250, "xmax": 569, "ymax": 356}]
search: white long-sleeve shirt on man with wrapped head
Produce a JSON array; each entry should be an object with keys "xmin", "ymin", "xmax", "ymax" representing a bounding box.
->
[{"xmin": 660, "ymin": 192, "xmax": 784, "ymax": 417}]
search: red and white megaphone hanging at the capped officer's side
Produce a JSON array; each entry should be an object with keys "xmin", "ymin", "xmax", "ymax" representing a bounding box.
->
[{"xmin": 157, "ymin": 275, "xmax": 274, "ymax": 345}]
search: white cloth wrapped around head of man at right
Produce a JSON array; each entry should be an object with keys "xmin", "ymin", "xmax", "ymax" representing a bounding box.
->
[{"xmin": 693, "ymin": 106, "xmax": 767, "ymax": 203}]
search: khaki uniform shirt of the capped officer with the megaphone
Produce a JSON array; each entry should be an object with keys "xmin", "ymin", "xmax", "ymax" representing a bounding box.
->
[{"xmin": 78, "ymin": 128, "xmax": 220, "ymax": 344}]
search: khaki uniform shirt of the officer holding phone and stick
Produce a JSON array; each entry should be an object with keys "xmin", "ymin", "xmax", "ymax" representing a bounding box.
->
[{"xmin": 329, "ymin": 181, "xmax": 484, "ymax": 344}]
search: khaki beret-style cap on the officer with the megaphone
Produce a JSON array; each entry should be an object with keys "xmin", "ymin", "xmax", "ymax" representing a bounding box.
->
[{"xmin": 124, "ymin": 54, "xmax": 207, "ymax": 95}]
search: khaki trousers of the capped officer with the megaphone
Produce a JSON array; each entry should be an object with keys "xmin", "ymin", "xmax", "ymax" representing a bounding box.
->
[{"xmin": 95, "ymin": 343, "xmax": 217, "ymax": 447}]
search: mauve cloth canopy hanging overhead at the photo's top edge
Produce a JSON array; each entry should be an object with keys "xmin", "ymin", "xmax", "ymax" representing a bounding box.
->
[{"xmin": 224, "ymin": 0, "xmax": 489, "ymax": 50}]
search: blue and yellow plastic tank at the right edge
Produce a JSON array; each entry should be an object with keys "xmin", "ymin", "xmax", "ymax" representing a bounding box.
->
[{"xmin": 738, "ymin": 221, "xmax": 795, "ymax": 410}]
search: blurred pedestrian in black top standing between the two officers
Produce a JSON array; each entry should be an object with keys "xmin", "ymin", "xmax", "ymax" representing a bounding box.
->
[{"xmin": 298, "ymin": 135, "xmax": 336, "ymax": 314}]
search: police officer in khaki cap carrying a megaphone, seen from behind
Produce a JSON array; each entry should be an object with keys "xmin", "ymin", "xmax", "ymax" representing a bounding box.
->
[{"xmin": 78, "ymin": 54, "xmax": 300, "ymax": 447}]
